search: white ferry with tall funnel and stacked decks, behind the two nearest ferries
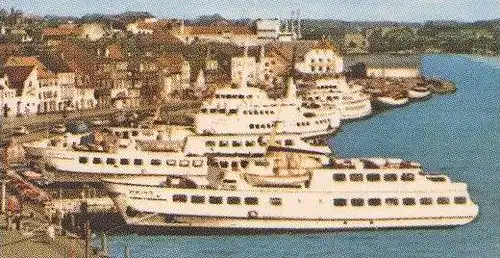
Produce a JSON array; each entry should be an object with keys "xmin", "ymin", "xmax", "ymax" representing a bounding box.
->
[{"xmin": 195, "ymin": 78, "xmax": 340, "ymax": 137}]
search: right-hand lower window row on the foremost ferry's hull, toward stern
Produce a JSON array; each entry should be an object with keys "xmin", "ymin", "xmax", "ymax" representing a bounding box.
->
[{"xmin": 333, "ymin": 196, "xmax": 467, "ymax": 207}]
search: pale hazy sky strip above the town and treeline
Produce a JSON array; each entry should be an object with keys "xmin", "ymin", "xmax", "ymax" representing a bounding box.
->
[{"xmin": 0, "ymin": 0, "xmax": 500, "ymax": 22}]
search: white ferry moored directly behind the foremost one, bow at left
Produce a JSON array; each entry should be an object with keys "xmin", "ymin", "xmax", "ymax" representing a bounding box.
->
[{"xmin": 24, "ymin": 127, "xmax": 331, "ymax": 182}]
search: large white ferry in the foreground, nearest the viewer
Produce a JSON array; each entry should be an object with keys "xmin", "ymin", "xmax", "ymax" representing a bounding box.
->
[{"xmin": 102, "ymin": 151, "xmax": 478, "ymax": 234}]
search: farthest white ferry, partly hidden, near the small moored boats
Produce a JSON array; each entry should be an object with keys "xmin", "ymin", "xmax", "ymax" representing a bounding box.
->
[{"xmin": 302, "ymin": 75, "xmax": 372, "ymax": 120}]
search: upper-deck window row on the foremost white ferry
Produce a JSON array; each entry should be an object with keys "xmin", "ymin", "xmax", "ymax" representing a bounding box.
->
[{"xmin": 333, "ymin": 173, "xmax": 415, "ymax": 182}]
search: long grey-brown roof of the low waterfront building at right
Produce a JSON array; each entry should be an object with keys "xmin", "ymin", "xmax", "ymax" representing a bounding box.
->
[{"xmin": 344, "ymin": 54, "xmax": 421, "ymax": 69}]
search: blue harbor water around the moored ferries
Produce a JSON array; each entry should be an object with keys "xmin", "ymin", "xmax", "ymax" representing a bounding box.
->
[{"xmin": 103, "ymin": 55, "xmax": 500, "ymax": 257}]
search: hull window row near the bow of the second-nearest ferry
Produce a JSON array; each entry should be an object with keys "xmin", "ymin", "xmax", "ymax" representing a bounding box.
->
[{"xmin": 78, "ymin": 157, "xmax": 203, "ymax": 167}]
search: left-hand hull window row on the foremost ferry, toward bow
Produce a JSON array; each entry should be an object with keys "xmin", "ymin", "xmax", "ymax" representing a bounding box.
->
[{"xmin": 172, "ymin": 194, "xmax": 262, "ymax": 205}]
